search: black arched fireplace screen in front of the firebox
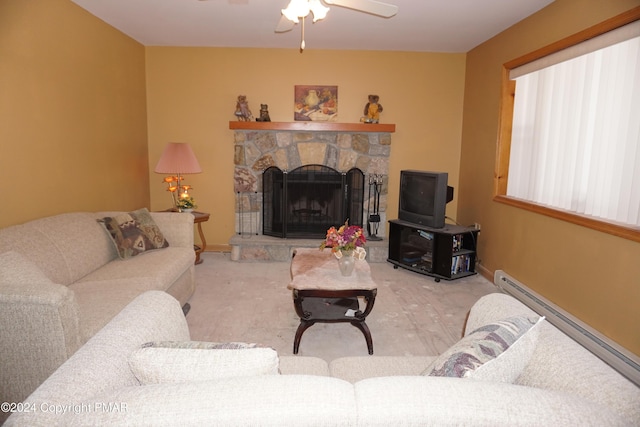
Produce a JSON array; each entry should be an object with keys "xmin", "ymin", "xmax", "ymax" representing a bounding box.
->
[{"xmin": 262, "ymin": 165, "xmax": 364, "ymax": 238}]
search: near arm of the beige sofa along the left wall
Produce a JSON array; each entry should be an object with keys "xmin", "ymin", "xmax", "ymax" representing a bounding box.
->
[{"xmin": 0, "ymin": 251, "xmax": 80, "ymax": 414}]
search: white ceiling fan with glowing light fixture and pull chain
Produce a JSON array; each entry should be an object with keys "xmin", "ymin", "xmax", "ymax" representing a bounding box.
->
[{"xmin": 275, "ymin": 0, "xmax": 398, "ymax": 52}]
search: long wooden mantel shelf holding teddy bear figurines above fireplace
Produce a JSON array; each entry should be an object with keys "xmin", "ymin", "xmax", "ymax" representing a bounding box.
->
[{"xmin": 229, "ymin": 121, "xmax": 396, "ymax": 133}]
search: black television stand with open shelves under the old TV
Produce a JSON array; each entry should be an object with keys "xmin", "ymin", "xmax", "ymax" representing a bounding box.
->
[{"xmin": 387, "ymin": 219, "xmax": 478, "ymax": 282}]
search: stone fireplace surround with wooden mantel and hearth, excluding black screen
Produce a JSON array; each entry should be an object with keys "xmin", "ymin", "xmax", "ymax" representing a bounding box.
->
[{"xmin": 229, "ymin": 122, "xmax": 395, "ymax": 262}]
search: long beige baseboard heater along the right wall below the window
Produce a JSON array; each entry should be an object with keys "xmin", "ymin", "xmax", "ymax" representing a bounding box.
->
[{"xmin": 493, "ymin": 270, "xmax": 640, "ymax": 386}]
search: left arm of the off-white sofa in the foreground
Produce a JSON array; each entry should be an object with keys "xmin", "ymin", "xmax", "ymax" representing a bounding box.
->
[{"xmin": 7, "ymin": 291, "xmax": 189, "ymax": 426}]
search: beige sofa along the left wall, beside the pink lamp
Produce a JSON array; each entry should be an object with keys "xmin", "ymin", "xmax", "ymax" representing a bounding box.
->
[{"xmin": 0, "ymin": 211, "xmax": 195, "ymax": 421}]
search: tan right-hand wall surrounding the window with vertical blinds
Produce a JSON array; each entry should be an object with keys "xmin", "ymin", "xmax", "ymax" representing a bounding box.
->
[{"xmin": 458, "ymin": 0, "xmax": 640, "ymax": 355}]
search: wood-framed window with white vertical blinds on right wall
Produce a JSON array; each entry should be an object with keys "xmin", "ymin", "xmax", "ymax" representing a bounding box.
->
[{"xmin": 496, "ymin": 9, "xmax": 640, "ymax": 241}]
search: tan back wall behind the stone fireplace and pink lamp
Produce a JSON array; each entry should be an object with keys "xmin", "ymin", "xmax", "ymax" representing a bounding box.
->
[{"xmin": 147, "ymin": 46, "xmax": 465, "ymax": 251}]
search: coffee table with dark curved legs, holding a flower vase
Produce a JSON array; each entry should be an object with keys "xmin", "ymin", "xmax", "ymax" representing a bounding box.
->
[{"xmin": 288, "ymin": 248, "xmax": 378, "ymax": 354}]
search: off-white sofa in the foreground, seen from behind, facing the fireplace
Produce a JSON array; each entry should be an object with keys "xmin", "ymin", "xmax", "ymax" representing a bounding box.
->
[{"xmin": 7, "ymin": 292, "xmax": 640, "ymax": 426}]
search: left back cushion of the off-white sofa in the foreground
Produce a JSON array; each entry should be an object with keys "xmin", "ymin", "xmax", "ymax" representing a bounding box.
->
[{"xmin": 61, "ymin": 375, "xmax": 358, "ymax": 427}]
